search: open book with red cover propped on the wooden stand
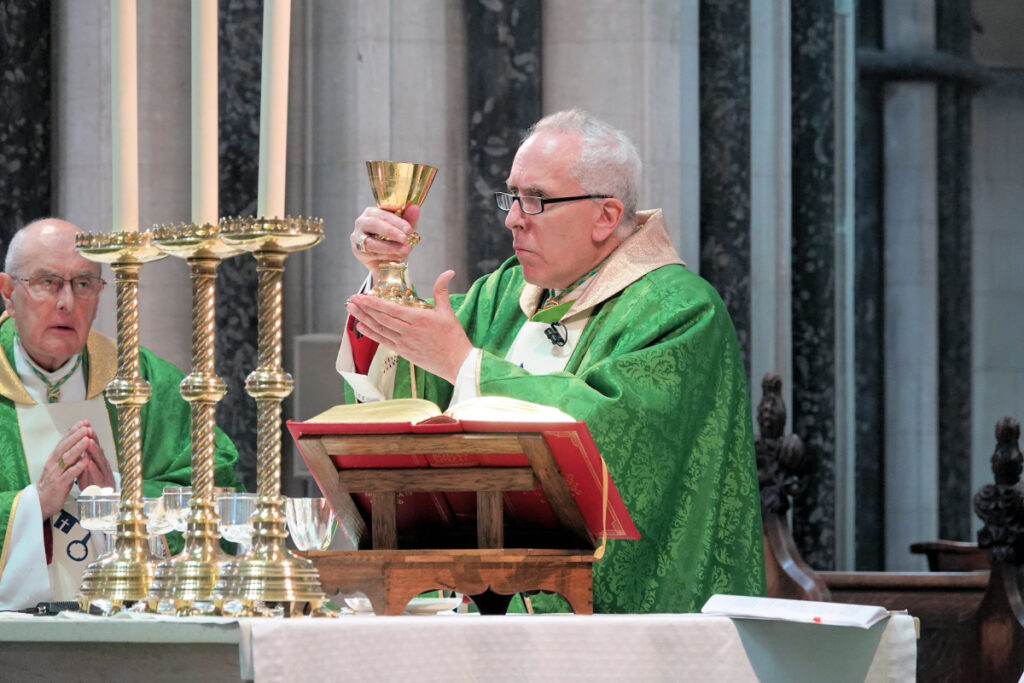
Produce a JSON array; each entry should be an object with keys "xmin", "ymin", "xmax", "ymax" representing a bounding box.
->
[{"xmin": 288, "ymin": 396, "xmax": 640, "ymax": 540}]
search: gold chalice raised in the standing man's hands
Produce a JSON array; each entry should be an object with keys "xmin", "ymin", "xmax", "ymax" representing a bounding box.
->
[{"xmin": 367, "ymin": 161, "xmax": 437, "ymax": 308}]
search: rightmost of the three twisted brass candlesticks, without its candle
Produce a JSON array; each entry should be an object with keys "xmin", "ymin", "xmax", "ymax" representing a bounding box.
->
[{"xmin": 214, "ymin": 217, "xmax": 332, "ymax": 616}]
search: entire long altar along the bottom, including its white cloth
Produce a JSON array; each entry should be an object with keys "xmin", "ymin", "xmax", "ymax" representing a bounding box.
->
[{"xmin": 0, "ymin": 614, "xmax": 916, "ymax": 683}]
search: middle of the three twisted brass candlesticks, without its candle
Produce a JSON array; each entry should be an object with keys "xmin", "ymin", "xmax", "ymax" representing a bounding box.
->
[{"xmin": 151, "ymin": 224, "xmax": 239, "ymax": 616}]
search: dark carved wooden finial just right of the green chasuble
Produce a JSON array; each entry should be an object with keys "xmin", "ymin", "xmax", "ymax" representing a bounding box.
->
[{"xmin": 754, "ymin": 373, "xmax": 806, "ymax": 515}]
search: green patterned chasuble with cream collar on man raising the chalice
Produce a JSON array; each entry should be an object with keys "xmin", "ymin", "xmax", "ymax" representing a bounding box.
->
[{"xmin": 376, "ymin": 211, "xmax": 765, "ymax": 612}]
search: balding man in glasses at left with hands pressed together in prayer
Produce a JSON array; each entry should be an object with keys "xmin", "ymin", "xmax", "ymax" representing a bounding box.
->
[{"xmin": 0, "ymin": 218, "xmax": 239, "ymax": 609}]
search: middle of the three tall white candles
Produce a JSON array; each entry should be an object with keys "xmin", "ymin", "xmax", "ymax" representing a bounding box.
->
[{"xmin": 191, "ymin": 0, "xmax": 219, "ymax": 225}]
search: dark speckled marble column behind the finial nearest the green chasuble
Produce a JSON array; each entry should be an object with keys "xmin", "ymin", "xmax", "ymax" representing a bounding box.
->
[{"xmin": 791, "ymin": 3, "xmax": 837, "ymax": 569}]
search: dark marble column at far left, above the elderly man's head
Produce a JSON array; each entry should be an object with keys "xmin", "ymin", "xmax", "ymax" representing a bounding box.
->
[{"xmin": 0, "ymin": 0, "xmax": 52, "ymax": 250}]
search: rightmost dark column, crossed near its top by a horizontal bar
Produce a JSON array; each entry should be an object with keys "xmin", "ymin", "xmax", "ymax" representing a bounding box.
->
[{"xmin": 935, "ymin": 0, "xmax": 970, "ymax": 541}]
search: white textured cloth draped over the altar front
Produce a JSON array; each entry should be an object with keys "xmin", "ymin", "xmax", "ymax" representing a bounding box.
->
[{"xmin": 248, "ymin": 614, "xmax": 916, "ymax": 683}]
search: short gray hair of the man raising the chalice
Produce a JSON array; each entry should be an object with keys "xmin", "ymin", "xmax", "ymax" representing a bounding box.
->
[{"xmin": 526, "ymin": 109, "xmax": 643, "ymax": 229}]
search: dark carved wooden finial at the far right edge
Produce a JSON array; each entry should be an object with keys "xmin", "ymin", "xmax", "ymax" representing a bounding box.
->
[{"xmin": 974, "ymin": 417, "xmax": 1024, "ymax": 564}]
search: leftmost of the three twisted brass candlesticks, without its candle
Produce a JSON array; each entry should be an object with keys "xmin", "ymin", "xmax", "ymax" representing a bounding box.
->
[{"xmin": 75, "ymin": 231, "xmax": 164, "ymax": 614}]
